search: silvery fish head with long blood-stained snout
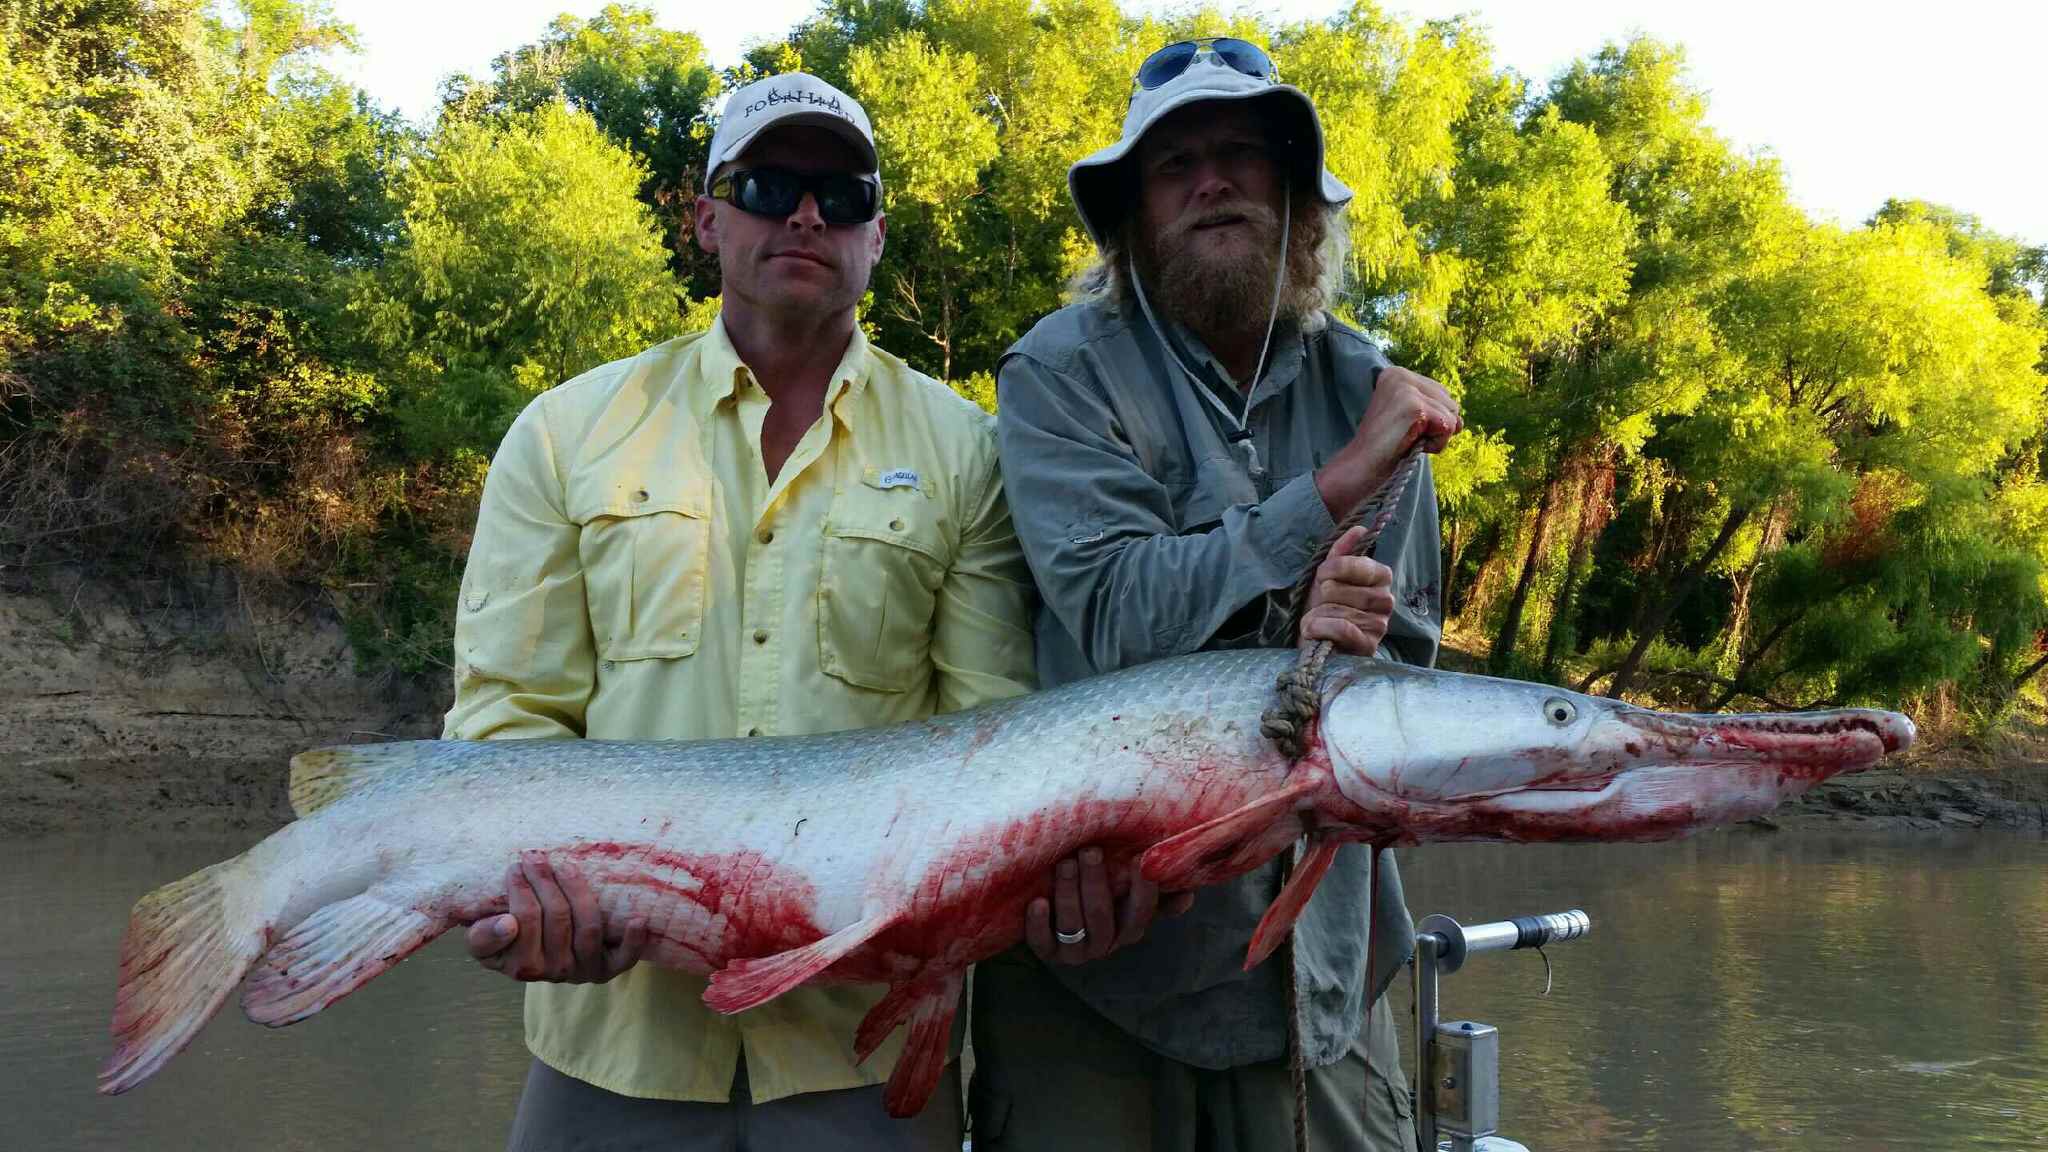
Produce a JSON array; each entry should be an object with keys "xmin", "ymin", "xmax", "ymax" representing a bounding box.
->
[{"xmin": 1321, "ymin": 662, "xmax": 1915, "ymax": 842}]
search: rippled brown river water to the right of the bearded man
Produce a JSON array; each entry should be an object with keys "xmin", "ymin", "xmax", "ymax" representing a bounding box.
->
[{"xmin": 1395, "ymin": 832, "xmax": 2048, "ymax": 1152}]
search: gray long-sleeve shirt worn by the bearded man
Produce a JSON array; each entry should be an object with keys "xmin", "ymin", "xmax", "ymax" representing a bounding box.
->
[{"xmin": 997, "ymin": 293, "xmax": 1442, "ymax": 1068}]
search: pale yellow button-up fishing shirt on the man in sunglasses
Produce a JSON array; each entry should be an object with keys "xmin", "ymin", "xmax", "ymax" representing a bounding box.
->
[{"xmin": 444, "ymin": 322, "xmax": 1032, "ymax": 1103}]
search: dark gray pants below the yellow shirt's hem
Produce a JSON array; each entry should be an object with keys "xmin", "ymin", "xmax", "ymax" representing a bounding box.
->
[{"xmin": 506, "ymin": 1060, "xmax": 961, "ymax": 1152}]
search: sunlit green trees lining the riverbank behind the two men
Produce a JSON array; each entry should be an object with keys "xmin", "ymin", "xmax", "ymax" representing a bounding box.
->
[{"xmin": 0, "ymin": 0, "xmax": 2048, "ymax": 726}]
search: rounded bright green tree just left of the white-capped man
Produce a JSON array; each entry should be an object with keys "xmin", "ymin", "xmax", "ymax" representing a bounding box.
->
[{"xmin": 360, "ymin": 105, "xmax": 678, "ymax": 457}]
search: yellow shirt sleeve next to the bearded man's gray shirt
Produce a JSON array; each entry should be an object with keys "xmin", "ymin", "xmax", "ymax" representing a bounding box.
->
[{"xmin": 932, "ymin": 426, "xmax": 1036, "ymax": 711}]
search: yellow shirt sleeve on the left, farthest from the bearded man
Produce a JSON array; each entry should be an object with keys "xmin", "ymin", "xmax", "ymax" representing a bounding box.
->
[{"xmin": 442, "ymin": 396, "xmax": 596, "ymax": 740}]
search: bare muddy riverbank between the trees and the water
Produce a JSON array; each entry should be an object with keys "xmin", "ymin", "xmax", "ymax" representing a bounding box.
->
[{"xmin": 0, "ymin": 572, "xmax": 2048, "ymax": 836}]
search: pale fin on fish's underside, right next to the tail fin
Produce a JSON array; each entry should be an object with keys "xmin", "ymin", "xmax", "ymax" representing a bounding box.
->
[{"xmin": 242, "ymin": 892, "xmax": 449, "ymax": 1027}]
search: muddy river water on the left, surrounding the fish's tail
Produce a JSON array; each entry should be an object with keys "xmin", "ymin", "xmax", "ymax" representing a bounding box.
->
[{"xmin": 0, "ymin": 834, "xmax": 526, "ymax": 1152}]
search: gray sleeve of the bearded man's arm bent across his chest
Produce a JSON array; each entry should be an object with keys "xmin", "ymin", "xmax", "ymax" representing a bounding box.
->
[{"xmin": 997, "ymin": 353, "xmax": 1335, "ymax": 672}]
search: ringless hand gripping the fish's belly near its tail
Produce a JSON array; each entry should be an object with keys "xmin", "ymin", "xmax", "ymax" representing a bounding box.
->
[{"xmin": 467, "ymin": 853, "xmax": 647, "ymax": 984}]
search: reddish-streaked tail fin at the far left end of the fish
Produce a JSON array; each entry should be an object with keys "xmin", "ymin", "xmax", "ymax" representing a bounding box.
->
[{"xmin": 100, "ymin": 861, "xmax": 264, "ymax": 1097}]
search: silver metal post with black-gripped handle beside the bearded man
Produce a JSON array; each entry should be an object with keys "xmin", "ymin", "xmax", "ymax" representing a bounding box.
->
[{"xmin": 1413, "ymin": 908, "xmax": 1593, "ymax": 1152}]
